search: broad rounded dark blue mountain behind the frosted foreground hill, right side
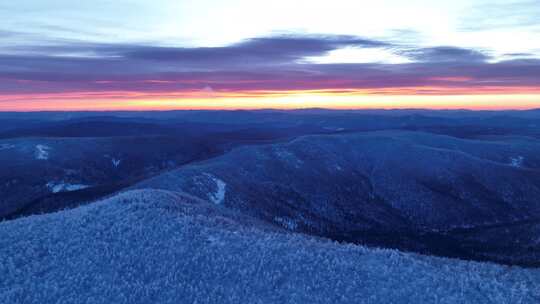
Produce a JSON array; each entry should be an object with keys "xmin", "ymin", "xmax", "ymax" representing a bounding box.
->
[{"xmin": 135, "ymin": 131, "xmax": 540, "ymax": 266}]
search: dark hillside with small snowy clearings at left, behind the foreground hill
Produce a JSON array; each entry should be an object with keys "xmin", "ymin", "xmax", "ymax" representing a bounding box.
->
[{"xmin": 0, "ymin": 135, "xmax": 219, "ymax": 219}]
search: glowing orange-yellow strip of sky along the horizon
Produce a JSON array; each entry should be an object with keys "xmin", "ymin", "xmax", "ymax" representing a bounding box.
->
[{"xmin": 0, "ymin": 87, "xmax": 540, "ymax": 111}]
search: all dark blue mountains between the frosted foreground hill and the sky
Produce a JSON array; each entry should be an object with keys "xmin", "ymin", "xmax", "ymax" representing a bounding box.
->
[{"xmin": 0, "ymin": 109, "xmax": 540, "ymax": 266}]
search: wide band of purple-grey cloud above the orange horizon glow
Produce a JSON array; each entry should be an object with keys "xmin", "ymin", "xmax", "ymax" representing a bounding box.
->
[{"xmin": 0, "ymin": 35, "xmax": 540, "ymax": 95}]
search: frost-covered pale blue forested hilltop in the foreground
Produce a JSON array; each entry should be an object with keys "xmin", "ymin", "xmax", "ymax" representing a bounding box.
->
[{"xmin": 0, "ymin": 190, "xmax": 540, "ymax": 303}]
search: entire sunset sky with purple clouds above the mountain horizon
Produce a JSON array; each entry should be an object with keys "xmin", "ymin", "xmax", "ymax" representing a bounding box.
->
[{"xmin": 0, "ymin": 0, "xmax": 540, "ymax": 111}]
